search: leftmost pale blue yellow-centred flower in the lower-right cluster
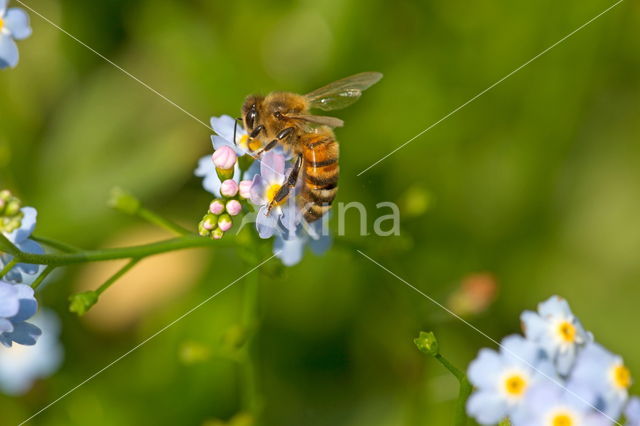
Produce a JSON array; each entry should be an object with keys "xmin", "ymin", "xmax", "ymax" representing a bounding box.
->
[{"xmin": 467, "ymin": 335, "xmax": 557, "ymax": 425}]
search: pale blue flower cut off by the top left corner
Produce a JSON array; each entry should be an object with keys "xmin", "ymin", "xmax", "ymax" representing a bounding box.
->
[{"xmin": 0, "ymin": 0, "xmax": 31, "ymax": 69}]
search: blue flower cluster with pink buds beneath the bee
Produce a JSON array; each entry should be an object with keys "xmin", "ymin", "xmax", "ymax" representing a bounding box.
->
[{"xmin": 195, "ymin": 115, "xmax": 331, "ymax": 266}]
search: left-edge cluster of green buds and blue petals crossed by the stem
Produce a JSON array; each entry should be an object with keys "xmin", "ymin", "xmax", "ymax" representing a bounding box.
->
[{"xmin": 0, "ymin": 190, "xmax": 44, "ymax": 283}]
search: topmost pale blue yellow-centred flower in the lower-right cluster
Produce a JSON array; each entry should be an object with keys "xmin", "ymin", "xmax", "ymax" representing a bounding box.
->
[{"xmin": 521, "ymin": 296, "xmax": 593, "ymax": 376}]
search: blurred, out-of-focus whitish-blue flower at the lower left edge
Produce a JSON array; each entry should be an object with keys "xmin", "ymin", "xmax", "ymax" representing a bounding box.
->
[{"xmin": 0, "ymin": 310, "xmax": 63, "ymax": 395}]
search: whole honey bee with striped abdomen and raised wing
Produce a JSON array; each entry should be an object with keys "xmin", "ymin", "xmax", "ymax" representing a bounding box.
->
[{"xmin": 241, "ymin": 72, "xmax": 382, "ymax": 223}]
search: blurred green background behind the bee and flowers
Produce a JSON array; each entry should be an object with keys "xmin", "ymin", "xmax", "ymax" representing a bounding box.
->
[{"xmin": 0, "ymin": 0, "xmax": 640, "ymax": 426}]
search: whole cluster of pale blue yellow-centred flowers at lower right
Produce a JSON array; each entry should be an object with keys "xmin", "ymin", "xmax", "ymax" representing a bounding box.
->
[{"xmin": 467, "ymin": 296, "xmax": 640, "ymax": 426}]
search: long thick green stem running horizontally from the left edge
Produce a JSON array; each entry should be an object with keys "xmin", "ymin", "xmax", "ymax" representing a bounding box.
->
[{"xmin": 0, "ymin": 234, "xmax": 233, "ymax": 266}]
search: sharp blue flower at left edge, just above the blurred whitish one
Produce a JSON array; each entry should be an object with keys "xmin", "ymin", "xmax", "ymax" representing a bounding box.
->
[{"xmin": 0, "ymin": 280, "xmax": 42, "ymax": 348}]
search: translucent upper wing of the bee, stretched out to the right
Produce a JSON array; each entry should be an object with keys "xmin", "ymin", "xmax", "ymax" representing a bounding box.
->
[{"xmin": 305, "ymin": 72, "xmax": 382, "ymax": 111}]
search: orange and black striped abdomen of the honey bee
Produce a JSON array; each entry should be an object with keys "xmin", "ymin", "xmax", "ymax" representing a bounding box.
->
[{"xmin": 300, "ymin": 129, "xmax": 340, "ymax": 222}]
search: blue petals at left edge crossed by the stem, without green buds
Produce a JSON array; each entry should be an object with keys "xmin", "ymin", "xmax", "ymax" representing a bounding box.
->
[{"xmin": 0, "ymin": 207, "xmax": 44, "ymax": 283}]
